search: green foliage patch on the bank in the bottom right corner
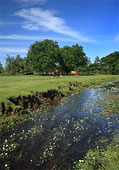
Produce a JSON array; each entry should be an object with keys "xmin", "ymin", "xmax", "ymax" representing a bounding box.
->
[{"xmin": 74, "ymin": 137, "xmax": 119, "ymax": 170}]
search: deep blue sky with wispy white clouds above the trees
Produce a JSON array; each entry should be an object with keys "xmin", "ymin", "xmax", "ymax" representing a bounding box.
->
[{"xmin": 0, "ymin": 0, "xmax": 119, "ymax": 66}]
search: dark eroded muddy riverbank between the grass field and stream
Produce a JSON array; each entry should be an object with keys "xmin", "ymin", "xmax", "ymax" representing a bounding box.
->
[{"xmin": 1, "ymin": 82, "xmax": 80, "ymax": 116}]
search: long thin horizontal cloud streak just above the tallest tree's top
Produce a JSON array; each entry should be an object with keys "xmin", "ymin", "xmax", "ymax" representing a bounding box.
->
[{"xmin": 0, "ymin": 34, "xmax": 84, "ymax": 42}]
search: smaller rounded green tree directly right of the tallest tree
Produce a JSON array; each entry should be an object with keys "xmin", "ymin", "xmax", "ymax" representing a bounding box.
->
[{"xmin": 60, "ymin": 44, "xmax": 88, "ymax": 73}]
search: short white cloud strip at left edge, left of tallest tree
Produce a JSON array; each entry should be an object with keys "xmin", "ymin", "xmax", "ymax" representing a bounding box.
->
[{"xmin": 0, "ymin": 47, "xmax": 28, "ymax": 53}]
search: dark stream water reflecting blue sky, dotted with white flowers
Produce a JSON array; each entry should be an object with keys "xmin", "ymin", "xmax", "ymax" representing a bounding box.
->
[{"xmin": 0, "ymin": 83, "xmax": 119, "ymax": 170}]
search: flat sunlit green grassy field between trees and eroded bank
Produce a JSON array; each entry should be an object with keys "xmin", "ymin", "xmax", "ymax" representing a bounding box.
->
[{"xmin": 0, "ymin": 75, "xmax": 119, "ymax": 103}]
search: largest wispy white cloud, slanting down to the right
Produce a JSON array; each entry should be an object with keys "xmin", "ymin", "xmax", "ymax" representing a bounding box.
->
[{"xmin": 15, "ymin": 8, "xmax": 95, "ymax": 43}]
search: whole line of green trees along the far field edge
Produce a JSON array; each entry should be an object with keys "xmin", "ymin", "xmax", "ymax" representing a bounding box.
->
[{"xmin": 0, "ymin": 39, "xmax": 119, "ymax": 75}]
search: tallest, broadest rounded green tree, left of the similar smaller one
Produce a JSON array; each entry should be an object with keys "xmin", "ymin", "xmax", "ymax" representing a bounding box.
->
[{"xmin": 26, "ymin": 39, "xmax": 59, "ymax": 72}]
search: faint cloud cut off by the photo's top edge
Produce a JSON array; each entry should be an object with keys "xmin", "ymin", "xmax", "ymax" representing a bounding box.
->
[{"xmin": 15, "ymin": 0, "xmax": 47, "ymax": 6}]
